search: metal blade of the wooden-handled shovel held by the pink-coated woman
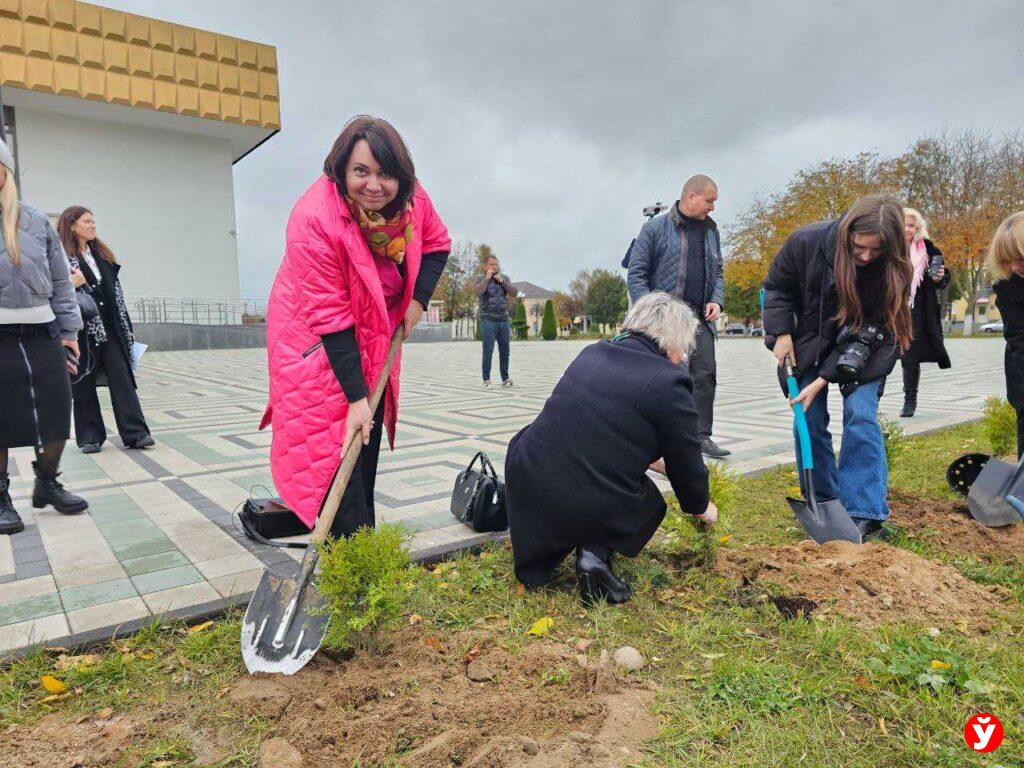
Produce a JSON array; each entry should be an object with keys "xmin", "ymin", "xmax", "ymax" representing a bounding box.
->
[{"xmin": 242, "ymin": 553, "xmax": 329, "ymax": 675}]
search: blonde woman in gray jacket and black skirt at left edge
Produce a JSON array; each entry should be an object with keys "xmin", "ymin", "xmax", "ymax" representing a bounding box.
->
[{"xmin": 0, "ymin": 141, "xmax": 89, "ymax": 535}]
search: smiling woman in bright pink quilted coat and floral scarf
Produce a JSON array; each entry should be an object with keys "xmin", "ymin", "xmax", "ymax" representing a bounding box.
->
[{"xmin": 260, "ymin": 116, "xmax": 452, "ymax": 537}]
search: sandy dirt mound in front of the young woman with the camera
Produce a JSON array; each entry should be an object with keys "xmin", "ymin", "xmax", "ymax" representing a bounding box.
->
[{"xmin": 718, "ymin": 541, "xmax": 1008, "ymax": 632}]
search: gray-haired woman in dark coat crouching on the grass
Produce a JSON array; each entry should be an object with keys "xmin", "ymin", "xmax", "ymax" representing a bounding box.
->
[{"xmin": 505, "ymin": 292, "xmax": 718, "ymax": 602}]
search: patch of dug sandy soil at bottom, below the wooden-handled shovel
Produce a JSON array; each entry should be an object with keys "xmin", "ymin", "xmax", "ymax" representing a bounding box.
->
[{"xmin": 254, "ymin": 628, "xmax": 657, "ymax": 768}]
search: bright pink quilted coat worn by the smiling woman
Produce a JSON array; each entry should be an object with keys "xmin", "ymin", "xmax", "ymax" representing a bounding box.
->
[{"xmin": 260, "ymin": 176, "xmax": 452, "ymax": 528}]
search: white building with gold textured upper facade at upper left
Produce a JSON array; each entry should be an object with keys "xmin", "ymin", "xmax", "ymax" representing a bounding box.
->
[{"xmin": 0, "ymin": 0, "xmax": 281, "ymax": 299}]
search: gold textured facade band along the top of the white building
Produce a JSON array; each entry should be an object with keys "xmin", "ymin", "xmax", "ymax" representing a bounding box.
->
[{"xmin": 0, "ymin": 0, "xmax": 281, "ymax": 129}]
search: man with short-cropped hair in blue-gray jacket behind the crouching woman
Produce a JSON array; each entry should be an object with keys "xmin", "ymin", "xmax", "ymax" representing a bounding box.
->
[{"xmin": 628, "ymin": 174, "xmax": 732, "ymax": 459}]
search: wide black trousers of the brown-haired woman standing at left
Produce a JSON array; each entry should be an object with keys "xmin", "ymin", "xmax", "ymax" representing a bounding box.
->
[{"xmin": 72, "ymin": 339, "xmax": 150, "ymax": 447}]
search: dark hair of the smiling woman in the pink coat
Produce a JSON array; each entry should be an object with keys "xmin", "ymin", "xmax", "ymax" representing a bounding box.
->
[{"xmin": 324, "ymin": 115, "xmax": 416, "ymax": 216}]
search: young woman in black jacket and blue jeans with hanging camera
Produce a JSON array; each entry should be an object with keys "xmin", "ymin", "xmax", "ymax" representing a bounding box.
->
[{"xmin": 764, "ymin": 195, "xmax": 913, "ymax": 538}]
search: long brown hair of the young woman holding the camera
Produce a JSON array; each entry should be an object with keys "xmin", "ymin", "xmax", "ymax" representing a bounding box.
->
[{"xmin": 835, "ymin": 195, "xmax": 913, "ymax": 351}]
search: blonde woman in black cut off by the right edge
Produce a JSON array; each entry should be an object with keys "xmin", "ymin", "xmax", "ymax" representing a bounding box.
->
[{"xmin": 985, "ymin": 211, "xmax": 1024, "ymax": 459}]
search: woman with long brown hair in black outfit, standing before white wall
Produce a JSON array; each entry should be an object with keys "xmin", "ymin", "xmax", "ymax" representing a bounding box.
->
[{"xmin": 57, "ymin": 206, "xmax": 156, "ymax": 454}]
